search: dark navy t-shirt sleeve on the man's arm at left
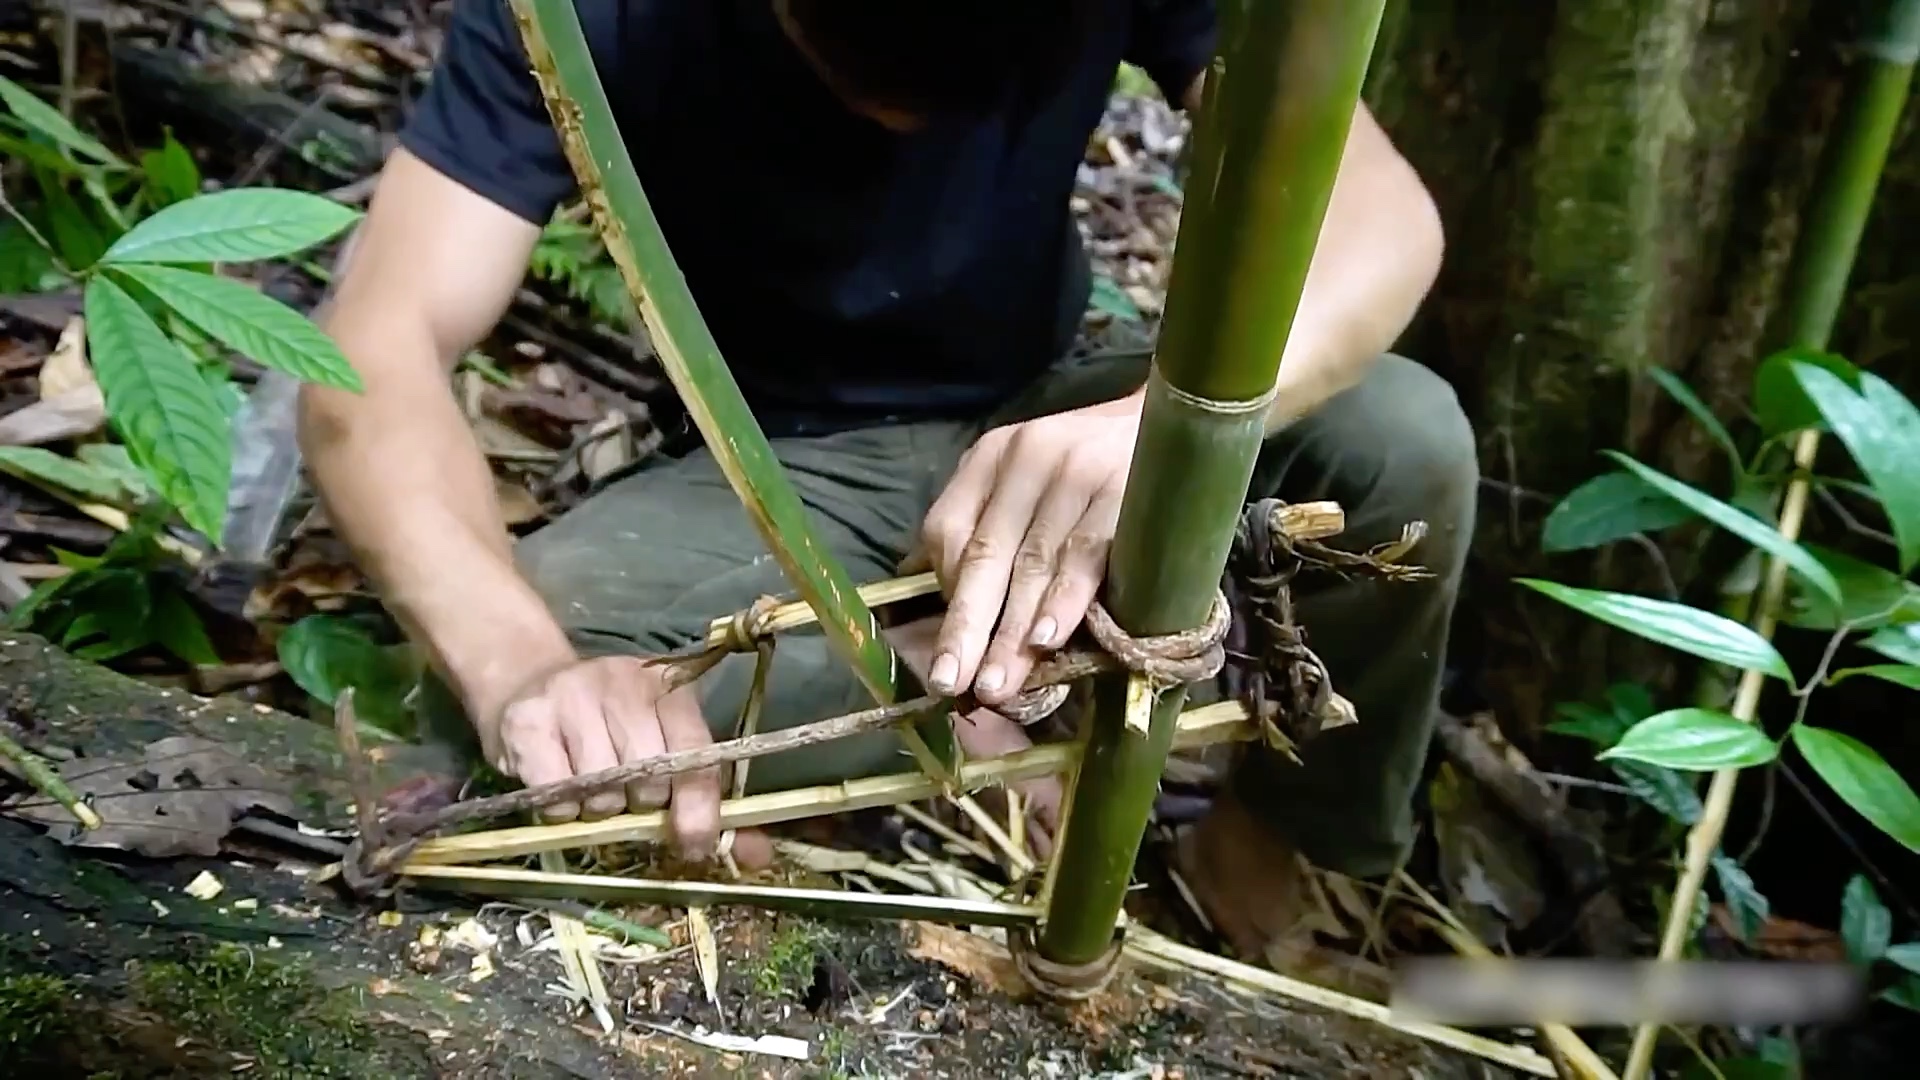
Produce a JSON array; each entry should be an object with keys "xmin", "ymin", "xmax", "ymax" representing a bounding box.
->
[{"xmin": 399, "ymin": 0, "xmax": 574, "ymax": 225}]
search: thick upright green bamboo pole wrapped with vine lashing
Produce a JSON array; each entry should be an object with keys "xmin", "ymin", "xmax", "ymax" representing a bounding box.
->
[{"xmin": 1039, "ymin": 0, "xmax": 1382, "ymax": 965}]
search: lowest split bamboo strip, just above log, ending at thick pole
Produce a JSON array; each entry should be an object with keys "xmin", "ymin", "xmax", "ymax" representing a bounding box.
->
[{"xmin": 405, "ymin": 867, "xmax": 1041, "ymax": 926}]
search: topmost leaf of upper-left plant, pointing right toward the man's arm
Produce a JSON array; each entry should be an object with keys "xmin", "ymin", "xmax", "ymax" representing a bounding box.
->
[{"xmin": 104, "ymin": 188, "xmax": 359, "ymax": 265}]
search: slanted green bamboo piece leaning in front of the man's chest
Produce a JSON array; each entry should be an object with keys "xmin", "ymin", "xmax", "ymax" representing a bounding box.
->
[{"xmin": 511, "ymin": 0, "xmax": 960, "ymax": 780}]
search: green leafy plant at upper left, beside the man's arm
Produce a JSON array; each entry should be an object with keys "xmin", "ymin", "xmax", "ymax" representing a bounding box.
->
[{"xmin": 0, "ymin": 79, "xmax": 361, "ymax": 544}]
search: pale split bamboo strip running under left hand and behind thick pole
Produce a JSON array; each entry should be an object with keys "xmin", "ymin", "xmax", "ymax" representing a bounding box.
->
[{"xmin": 399, "ymin": 701, "xmax": 1260, "ymax": 860}]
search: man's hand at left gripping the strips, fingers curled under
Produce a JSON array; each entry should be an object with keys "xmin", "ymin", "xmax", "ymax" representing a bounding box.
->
[{"xmin": 478, "ymin": 657, "xmax": 720, "ymax": 859}]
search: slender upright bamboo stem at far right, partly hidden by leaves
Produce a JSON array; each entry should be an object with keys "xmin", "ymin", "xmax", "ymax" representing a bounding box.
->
[{"xmin": 1624, "ymin": 0, "xmax": 1920, "ymax": 1080}]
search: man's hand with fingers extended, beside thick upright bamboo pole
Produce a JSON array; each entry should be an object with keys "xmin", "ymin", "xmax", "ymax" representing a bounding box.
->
[{"xmin": 922, "ymin": 394, "xmax": 1140, "ymax": 705}]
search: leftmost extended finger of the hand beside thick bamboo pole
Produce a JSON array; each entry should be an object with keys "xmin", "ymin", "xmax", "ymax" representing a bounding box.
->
[{"xmin": 927, "ymin": 451, "xmax": 1050, "ymax": 694}]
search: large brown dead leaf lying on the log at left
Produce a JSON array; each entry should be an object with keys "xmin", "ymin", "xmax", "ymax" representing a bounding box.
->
[{"xmin": 0, "ymin": 736, "xmax": 294, "ymax": 859}]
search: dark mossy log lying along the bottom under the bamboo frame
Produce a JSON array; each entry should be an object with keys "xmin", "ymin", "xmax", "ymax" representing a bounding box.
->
[{"xmin": 0, "ymin": 634, "xmax": 1528, "ymax": 1078}]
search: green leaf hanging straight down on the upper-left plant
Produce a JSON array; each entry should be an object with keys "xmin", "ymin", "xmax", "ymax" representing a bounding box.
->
[{"xmin": 86, "ymin": 269, "xmax": 232, "ymax": 544}]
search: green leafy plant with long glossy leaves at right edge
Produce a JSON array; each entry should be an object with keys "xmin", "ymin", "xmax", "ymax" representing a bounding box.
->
[{"xmin": 1523, "ymin": 350, "xmax": 1920, "ymax": 851}]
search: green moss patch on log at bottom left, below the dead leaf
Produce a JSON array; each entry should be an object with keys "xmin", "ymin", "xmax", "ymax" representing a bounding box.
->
[{"xmin": 132, "ymin": 945, "xmax": 426, "ymax": 1078}]
